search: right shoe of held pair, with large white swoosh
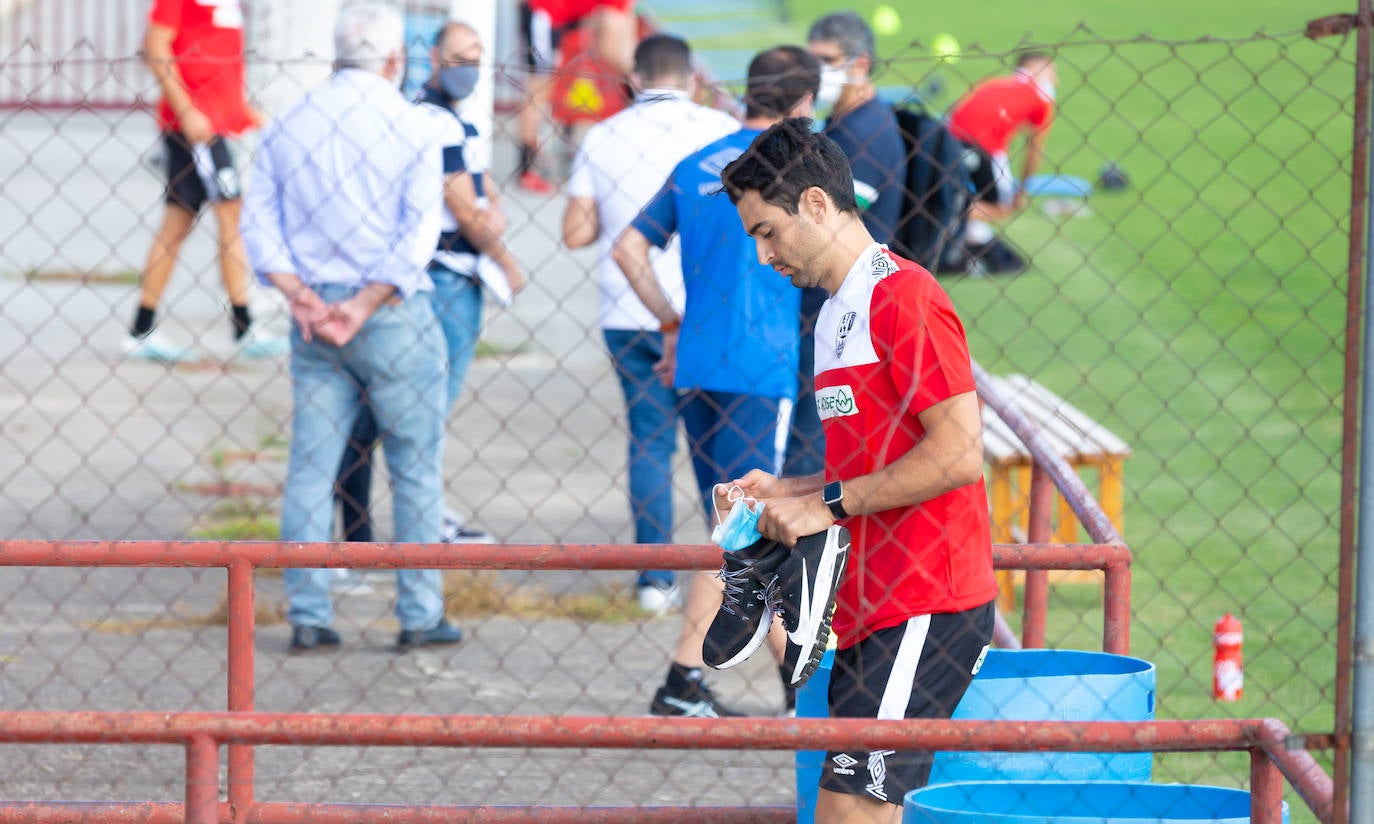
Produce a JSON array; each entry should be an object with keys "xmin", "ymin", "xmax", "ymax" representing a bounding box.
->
[{"xmin": 778, "ymin": 525, "xmax": 849, "ymax": 687}]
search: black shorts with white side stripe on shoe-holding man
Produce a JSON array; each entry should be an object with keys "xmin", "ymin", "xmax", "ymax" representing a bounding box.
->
[{"xmin": 820, "ymin": 602, "xmax": 993, "ymax": 805}]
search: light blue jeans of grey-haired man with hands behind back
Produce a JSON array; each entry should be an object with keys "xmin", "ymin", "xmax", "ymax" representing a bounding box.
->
[{"xmin": 282, "ymin": 286, "xmax": 445, "ymax": 629}]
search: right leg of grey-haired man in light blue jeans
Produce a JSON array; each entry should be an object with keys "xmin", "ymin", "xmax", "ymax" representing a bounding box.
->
[{"xmin": 350, "ymin": 295, "xmax": 447, "ymax": 632}]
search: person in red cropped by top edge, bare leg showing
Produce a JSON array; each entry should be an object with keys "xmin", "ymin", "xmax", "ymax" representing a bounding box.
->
[{"xmin": 515, "ymin": 0, "xmax": 639, "ymax": 195}]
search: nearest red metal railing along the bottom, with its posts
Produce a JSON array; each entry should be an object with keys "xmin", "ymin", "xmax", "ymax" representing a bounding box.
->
[{"xmin": 0, "ymin": 713, "xmax": 1331, "ymax": 824}]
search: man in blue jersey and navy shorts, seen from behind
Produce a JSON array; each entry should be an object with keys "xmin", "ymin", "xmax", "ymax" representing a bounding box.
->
[{"xmin": 614, "ymin": 47, "xmax": 820, "ymax": 717}]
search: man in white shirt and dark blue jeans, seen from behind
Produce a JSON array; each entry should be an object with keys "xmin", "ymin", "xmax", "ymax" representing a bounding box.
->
[{"xmin": 563, "ymin": 34, "xmax": 739, "ymax": 613}]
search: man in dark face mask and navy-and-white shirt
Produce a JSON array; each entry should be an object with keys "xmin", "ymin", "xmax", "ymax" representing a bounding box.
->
[{"xmin": 335, "ymin": 21, "xmax": 525, "ymax": 560}]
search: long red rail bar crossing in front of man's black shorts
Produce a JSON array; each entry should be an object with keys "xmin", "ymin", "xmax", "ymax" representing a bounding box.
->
[{"xmin": 0, "ymin": 711, "xmax": 1272, "ymax": 753}]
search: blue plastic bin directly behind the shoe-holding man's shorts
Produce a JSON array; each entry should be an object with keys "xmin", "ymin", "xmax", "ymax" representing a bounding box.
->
[{"xmin": 930, "ymin": 650, "xmax": 1156, "ymax": 784}]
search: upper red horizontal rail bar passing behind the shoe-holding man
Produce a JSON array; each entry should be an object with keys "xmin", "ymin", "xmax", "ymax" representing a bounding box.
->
[{"xmin": 0, "ymin": 541, "xmax": 1131, "ymax": 570}]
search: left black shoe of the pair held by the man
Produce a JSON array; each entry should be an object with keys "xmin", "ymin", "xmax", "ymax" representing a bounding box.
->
[{"xmin": 701, "ymin": 538, "xmax": 787, "ymax": 669}]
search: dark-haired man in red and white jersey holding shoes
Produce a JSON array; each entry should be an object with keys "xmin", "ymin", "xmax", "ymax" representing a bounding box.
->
[{"xmin": 721, "ymin": 118, "xmax": 996, "ymax": 824}]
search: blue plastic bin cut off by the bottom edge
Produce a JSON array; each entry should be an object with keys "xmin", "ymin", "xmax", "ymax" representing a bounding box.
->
[{"xmin": 901, "ymin": 781, "xmax": 1289, "ymax": 824}]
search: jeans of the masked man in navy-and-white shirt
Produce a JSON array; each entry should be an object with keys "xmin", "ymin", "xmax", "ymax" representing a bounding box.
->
[{"xmin": 334, "ymin": 264, "xmax": 482, "ymax": 542}]
